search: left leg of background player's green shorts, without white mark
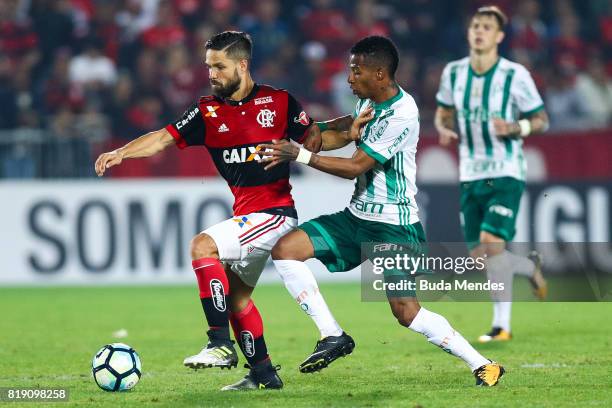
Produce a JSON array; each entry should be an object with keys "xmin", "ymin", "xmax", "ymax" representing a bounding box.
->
[{"xmin": 459, "ymin": 180, "xmax": 486, "ymax": 250}]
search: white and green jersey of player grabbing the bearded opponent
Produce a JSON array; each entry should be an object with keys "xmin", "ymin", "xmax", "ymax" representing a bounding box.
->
[{"xmin": 349, "ymin": 88, "xmax": 419, "ymax": 225}]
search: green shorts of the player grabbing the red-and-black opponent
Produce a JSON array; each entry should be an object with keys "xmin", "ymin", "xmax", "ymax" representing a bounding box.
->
[{"xmin": 298, "ymin": 208, "xmax": 426, "ymax": 296}]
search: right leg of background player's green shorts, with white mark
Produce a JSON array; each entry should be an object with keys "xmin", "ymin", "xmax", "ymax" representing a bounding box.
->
[{"xmin": 480, "ymin": 177, "xmax": 525, "ymax": 242}]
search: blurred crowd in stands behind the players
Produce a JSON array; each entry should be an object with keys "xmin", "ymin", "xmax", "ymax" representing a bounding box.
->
[{"xmin": 0, "ymin": 0, "xmax": 612, "ymax": 177}]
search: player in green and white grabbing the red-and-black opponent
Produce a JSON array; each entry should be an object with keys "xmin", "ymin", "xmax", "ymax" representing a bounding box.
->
[{"xmin": 262, "ymin": 36, "xmax": 504, "ymax": 386}]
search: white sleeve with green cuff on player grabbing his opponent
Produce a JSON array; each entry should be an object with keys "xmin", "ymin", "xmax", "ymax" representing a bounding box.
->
[{"xmin": 359, "ymin": 111, "xmax": 419, "ymax": 164}]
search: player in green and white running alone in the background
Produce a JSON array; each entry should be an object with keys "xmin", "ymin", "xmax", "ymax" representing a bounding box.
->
[{"xmin": 435, "ymin": 6, "xmax": 548, "ymax": 342}]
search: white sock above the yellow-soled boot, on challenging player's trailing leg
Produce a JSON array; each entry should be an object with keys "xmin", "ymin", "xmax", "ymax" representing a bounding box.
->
[{"xmin": 409, "ymin": 307, "xmax": 489, "ymax": 371}]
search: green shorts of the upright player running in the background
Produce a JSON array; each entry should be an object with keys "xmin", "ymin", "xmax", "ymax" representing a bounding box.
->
[{"xmin": 461, "ymin": 177, "xmax": 525, "ymax": 249}]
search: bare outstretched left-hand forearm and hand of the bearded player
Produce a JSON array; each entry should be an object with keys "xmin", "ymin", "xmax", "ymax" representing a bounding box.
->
[{"xmin": 94, "ymin": 129, "xmax": 174, "ymax": 176}]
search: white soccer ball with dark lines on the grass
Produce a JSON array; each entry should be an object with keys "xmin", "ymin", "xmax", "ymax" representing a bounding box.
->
[{"xmin": 91, "ymin": 343, "xmax": 142, "ymax": 391}]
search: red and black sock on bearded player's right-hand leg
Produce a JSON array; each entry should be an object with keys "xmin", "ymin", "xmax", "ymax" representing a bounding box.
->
[{"xmin": 230, "ymin": 300, "xmax": 270, "ymax": 367}]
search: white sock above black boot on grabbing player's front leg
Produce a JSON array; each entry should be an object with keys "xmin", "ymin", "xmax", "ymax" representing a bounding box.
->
[{"xmin": 274, "ymin": 260, "xmax": 342, "ymax": 337}]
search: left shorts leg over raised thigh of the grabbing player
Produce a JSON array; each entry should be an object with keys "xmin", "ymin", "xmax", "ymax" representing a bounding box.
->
[{"xmin": 298, "ymin": 209, "xmax": 361, "ymax": 272}]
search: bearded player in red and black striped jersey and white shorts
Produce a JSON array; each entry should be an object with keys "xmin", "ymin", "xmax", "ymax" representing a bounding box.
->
[{"xmin": 95, "ymin": 31, "xmax": 330, "ymax": 390}]
